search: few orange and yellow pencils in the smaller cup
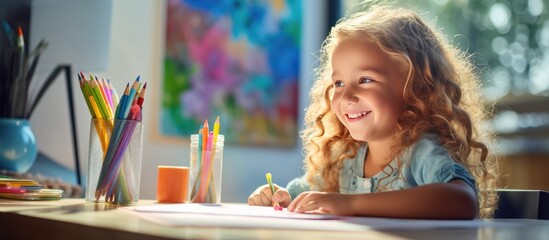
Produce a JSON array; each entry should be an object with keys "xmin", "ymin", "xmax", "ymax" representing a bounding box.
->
[{"xmin": 191, "ymin": 117, "xmax": 219, "ymax": 203}]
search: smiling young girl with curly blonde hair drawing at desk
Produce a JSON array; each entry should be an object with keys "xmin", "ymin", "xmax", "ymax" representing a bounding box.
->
[{"xmin": 248, "ymin": 6, "xmax": 497, "ymax": 219}]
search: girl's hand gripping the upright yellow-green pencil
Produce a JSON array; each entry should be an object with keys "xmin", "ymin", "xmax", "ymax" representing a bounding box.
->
[{"xmin": 248, "ymin": 184, "xmax": 292, "ymax": 207}]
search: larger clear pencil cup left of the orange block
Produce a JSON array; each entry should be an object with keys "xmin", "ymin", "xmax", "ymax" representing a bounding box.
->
[{"xmin": 86, "ymin": 119, "xmax": 143, "ymax": 205}]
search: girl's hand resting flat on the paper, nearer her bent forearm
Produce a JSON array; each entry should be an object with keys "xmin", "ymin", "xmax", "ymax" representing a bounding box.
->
[{"xmin": 288, "ymin": 192, "xmax": 356, "ymax": 215}]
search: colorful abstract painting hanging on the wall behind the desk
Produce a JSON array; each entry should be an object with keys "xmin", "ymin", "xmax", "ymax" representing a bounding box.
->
[{"xmin": 158, "ymin": 0, "xmax": 302, "ymax": 146}]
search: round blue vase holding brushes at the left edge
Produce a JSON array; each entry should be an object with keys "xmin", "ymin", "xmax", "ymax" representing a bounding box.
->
[{"xmin": 0, "ymin": 118, "xmax": 37, "ymax": 173}]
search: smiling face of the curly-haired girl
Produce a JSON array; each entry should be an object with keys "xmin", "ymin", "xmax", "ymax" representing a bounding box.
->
[{"xmin": 331, "ymin": 38, "xmax": 405, "ymax": 143}]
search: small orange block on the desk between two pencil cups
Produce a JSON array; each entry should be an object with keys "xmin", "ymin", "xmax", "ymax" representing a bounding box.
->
[{"xmin": 156, "ymin": 166, "xmax": 189, "ymax": 203}]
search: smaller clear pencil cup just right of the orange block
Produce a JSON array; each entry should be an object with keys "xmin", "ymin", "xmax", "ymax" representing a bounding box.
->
[{"xmin": 189, "ymin": 134, "xmax": 225, "ymax": 203}]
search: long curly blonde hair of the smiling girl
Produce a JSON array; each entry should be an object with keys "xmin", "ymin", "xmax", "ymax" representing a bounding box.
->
[{"xmin": 301, "ymin": 6, "xmax": 497, "ymax": 218}]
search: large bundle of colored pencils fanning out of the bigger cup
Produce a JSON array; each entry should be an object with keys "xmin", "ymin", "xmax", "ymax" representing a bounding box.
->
[{"xmin": 78, "ymin": 72, "xmax": 147, "ymax": 204}]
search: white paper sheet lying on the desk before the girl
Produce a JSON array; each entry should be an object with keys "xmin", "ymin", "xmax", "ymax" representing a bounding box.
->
[{"xmin": 122, "ymin": 204, "xmax": 521, "ymax": 231}]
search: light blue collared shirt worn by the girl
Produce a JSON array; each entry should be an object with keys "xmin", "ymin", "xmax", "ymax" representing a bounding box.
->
[{"xmin": 286, "ymin": 134, "xmax": 476, "ymax": 199}]
